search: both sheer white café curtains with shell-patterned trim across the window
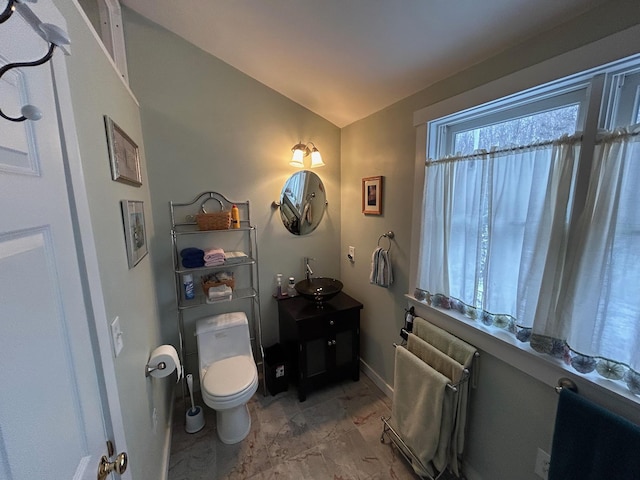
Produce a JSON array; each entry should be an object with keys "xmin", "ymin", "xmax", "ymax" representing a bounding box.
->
[{"xmin": 416, "ymin": 125, "xmax": 640, "ymax": 395}]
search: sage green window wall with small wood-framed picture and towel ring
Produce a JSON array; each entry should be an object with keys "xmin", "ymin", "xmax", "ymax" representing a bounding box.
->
[{"xmin": 341, "ymin": 0, "xmax": 640, "ymax": 480}]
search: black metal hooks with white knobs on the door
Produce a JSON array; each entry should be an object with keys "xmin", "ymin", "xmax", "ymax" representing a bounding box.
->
[{"xmin": 0, "ymin": 0, "xmax": 71, "ymax": 122}]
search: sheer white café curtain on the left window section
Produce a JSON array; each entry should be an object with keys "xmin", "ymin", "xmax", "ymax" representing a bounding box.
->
[{"xmin": 417, "ymin": 136, "xmax": 579, "ymax": 326}]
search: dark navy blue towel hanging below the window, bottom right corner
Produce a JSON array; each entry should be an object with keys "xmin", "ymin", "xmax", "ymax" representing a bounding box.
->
[{"xmin": 549, "ymin": 388, "xmax": 640, "ymax": 480}]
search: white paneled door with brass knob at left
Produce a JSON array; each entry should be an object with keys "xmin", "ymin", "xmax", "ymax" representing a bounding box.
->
[{"xmin": 0, "ymin": 1, "xmax": 124, "ymax": 480}]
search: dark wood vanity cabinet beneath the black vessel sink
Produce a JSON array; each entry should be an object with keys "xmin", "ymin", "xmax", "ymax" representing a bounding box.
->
[{"xmin": 278, "ymin": 292, "xmax": 362, "ymax": 402}]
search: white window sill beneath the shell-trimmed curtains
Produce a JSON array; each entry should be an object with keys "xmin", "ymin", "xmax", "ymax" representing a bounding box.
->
[{"xmin": 405, "ymin": 294, "xmax": 640, "ymax": 424}]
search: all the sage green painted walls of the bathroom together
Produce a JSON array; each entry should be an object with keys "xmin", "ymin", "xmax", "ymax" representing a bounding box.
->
[{"xmin": 54, "ymin": 0, "xmax": 640, "ymax": 480}]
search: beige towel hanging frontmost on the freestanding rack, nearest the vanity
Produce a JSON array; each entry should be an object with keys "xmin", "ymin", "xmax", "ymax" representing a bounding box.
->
[{"xmin": 390, "ymin": 346, "xmax": 450, "ymax": 476}]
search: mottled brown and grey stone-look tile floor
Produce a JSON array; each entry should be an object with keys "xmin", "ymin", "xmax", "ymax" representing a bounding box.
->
[{"xmin": 169, "ymin": 375, "xmax": 455, "ymax": 480}]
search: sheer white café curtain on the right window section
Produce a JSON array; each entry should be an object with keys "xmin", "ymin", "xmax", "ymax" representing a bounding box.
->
[{"xmin": 548, "ymin": 125, "xmax": 640, "ymax": 378}]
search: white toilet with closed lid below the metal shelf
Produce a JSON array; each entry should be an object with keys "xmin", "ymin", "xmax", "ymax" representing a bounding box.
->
[{"xmin": 196, "ymin": 312, "xmax": 258, "ymax": 444}]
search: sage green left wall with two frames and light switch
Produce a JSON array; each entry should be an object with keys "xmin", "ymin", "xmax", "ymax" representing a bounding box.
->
[{"xmin": 55, "ymin": 0, "xmax": 169, "ymax": 479}]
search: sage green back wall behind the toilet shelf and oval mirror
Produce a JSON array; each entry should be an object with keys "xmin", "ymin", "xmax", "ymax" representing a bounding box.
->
[{"xmin": 123, "ymin": 9, "xmax": 341, "ymax": 377}]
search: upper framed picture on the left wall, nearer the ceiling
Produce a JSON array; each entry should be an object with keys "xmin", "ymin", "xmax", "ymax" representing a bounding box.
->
[{"xmin": 104, "ymin": 115, "xmax": 142, "ymax": 187}]
